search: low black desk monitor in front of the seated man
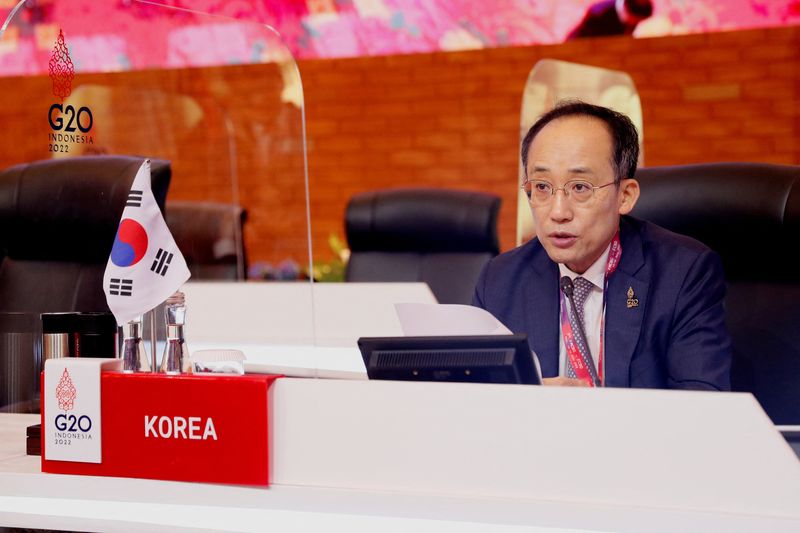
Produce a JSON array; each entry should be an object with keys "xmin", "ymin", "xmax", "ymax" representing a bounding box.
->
[{"xmin": 358, "ymin": 334, "xmax": 541, "ymax": 385}]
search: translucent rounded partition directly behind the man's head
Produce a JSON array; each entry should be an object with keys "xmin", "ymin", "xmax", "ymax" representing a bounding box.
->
[{"xmin": 515, "ymin": 59, "xmax": 644, "ymax": 245}]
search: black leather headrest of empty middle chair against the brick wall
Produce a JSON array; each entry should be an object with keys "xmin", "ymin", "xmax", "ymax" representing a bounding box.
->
[{"xmin": 345, "ymin": 189, "xmax": 500, "ymax": 254}]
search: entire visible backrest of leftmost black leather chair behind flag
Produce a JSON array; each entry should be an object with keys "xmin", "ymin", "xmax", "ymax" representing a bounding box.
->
[{"xmin": 0, "ymin": 156, "xmax": 171, "ymax": 313}]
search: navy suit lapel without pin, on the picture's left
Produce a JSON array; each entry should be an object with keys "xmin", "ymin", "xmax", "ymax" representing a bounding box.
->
[{"xmin": 523, "ymin": 245, "xmax": 561, "ymax": 377}]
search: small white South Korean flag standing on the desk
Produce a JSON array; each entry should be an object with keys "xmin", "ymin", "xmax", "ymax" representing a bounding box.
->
[{"xmin": 103, "ymin": 161, "xmax": 191, "ymax": 325}]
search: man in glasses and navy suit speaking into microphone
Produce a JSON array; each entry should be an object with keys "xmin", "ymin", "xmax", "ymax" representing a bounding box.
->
[{"xmin": 473, "ymin": 102, "xmax": 731, "ymax": 390}]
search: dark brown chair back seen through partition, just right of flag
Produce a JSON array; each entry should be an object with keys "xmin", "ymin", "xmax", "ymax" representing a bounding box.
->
[{"xmin": 166, "ymin": 201, "xmax": 247, "ymax": 281}]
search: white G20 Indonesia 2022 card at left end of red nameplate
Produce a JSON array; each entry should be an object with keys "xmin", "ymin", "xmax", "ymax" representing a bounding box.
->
[{"xmin": 43, "ymin": 358, "xmax": 121, "ymax": 463}]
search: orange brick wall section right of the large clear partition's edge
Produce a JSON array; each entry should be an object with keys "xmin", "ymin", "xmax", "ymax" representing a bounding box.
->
[{"xmin": 300, "ymin": 27, "xmax": 800, "ymax": 258}]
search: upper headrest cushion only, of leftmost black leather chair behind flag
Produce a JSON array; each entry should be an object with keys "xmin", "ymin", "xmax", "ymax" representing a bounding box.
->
[{"xmin": 0, "ymin": 156, "xmax": 171, "ymax": 263}]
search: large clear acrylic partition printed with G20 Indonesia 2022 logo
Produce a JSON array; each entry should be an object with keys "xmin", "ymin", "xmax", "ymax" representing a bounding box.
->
[{"xmin": 0, "ymin": 0, "xmax": 313, "ymax": 410}]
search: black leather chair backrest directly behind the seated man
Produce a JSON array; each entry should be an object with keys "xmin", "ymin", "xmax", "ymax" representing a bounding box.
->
[{"xmin": 633, "ymin": 163, "xmax": 800, "ymax": 424}]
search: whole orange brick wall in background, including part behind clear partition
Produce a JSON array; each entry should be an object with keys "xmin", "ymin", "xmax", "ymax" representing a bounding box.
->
[{"xmin": 0, "ymin": 27, "xmax": 800, "ymax": 261}]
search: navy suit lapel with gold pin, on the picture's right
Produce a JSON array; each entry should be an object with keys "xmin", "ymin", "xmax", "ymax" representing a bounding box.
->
[{"xmin": 605, "ymin": 219, "xmax": 650, "ymax": 387}]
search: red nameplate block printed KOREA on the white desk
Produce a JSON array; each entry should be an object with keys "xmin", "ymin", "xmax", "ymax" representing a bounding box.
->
[{"xmin": 41, "ymin": 372, "xmax": 279, "ymax": 486}]
